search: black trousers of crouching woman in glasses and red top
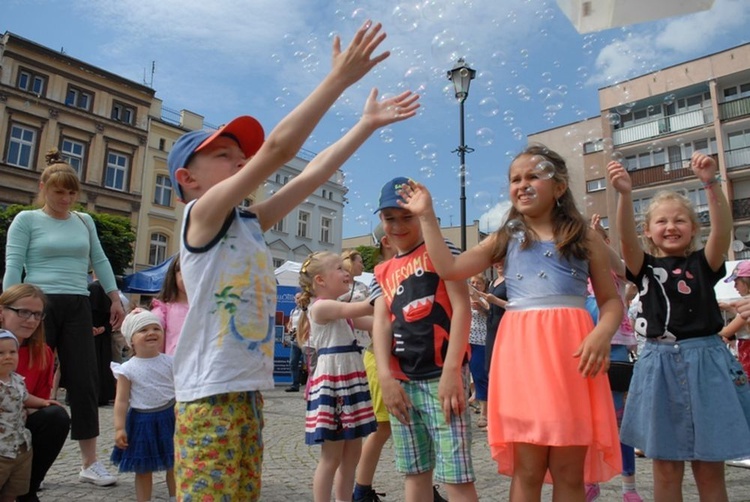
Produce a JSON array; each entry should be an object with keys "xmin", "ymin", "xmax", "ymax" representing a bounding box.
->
[{"xmin": 17, "ymin": 404, "xmax": 70, "ymax": 502}]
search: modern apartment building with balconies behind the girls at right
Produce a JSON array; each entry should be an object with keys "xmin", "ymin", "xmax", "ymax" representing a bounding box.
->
[{"xmin": 529, "ymin": 44, "xmax": 750, "ymax": 259}]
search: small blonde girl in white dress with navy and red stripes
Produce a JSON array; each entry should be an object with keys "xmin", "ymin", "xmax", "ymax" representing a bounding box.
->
[{"xmin": 298, "ymin": 252, "xmax": 377, "ymax": 502}]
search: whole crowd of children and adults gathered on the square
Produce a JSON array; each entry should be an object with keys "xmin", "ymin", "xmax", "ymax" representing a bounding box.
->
[{"xmin": 0, "ymin": 17, "xmax": 750, "ymax": 502}]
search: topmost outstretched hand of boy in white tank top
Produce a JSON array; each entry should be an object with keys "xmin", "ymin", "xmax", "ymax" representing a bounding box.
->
[{"xmin": 331, "ymin": 20, "xmax": 391, "ymax": 86}]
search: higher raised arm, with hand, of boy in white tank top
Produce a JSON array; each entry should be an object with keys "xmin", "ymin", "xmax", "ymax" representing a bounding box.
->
[{"xmin": 188, "ymin": 21, "xmax": 389, "ymax": 246}]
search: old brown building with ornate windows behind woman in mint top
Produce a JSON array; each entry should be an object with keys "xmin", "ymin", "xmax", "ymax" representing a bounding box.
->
[{"xmin": 0, "ymin": 32, "xmax": 154, "ymax": 226}]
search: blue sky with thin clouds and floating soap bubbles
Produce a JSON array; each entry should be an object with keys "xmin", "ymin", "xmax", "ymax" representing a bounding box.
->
[{"xmin": 0, "ymin": 0, "xmax": 750, "ymax": 237}]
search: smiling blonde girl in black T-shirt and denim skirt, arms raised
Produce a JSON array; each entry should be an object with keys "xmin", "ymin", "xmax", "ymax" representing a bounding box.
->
[{"xmin": 607, "ymin": 152, "xmax": 750, "ymax": 502}]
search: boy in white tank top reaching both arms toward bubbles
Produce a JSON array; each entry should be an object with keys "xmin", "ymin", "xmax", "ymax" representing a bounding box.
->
[{"xmin": 167, "ymin": 21, "xmax": 419, "ymax": 501}]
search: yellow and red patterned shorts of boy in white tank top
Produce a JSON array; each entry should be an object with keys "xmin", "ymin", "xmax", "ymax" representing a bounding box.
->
[{"xmin": 174, "ymin": 391, "xmax": 263, "ymax": 502}]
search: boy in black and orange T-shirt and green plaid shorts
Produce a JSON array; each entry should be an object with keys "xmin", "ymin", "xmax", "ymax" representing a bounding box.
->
[{"xmin": 371, "ymin": 177, "xmax": 477, "ymax": 502}]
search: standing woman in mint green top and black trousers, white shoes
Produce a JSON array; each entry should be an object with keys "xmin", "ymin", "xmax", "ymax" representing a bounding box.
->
[{"xmin": 3, "ymin": 149, "xmax": 124, "ymax": 486}]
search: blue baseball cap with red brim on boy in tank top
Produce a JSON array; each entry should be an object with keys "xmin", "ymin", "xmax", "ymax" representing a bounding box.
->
[{"xmin": 167, "ymin": 115, "xmax": 265, "ymax": 200}]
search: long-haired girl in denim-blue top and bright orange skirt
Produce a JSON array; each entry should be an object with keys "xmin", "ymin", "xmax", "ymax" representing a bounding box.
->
[{"xmin": 404, "ymin": 145, "xmax": 623, "ymax": 501}]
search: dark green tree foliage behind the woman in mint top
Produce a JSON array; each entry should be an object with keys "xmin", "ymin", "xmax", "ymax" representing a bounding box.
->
[{"xmin": 0, "ymin": 204, "xmax": 135, "ymax": 275}]
